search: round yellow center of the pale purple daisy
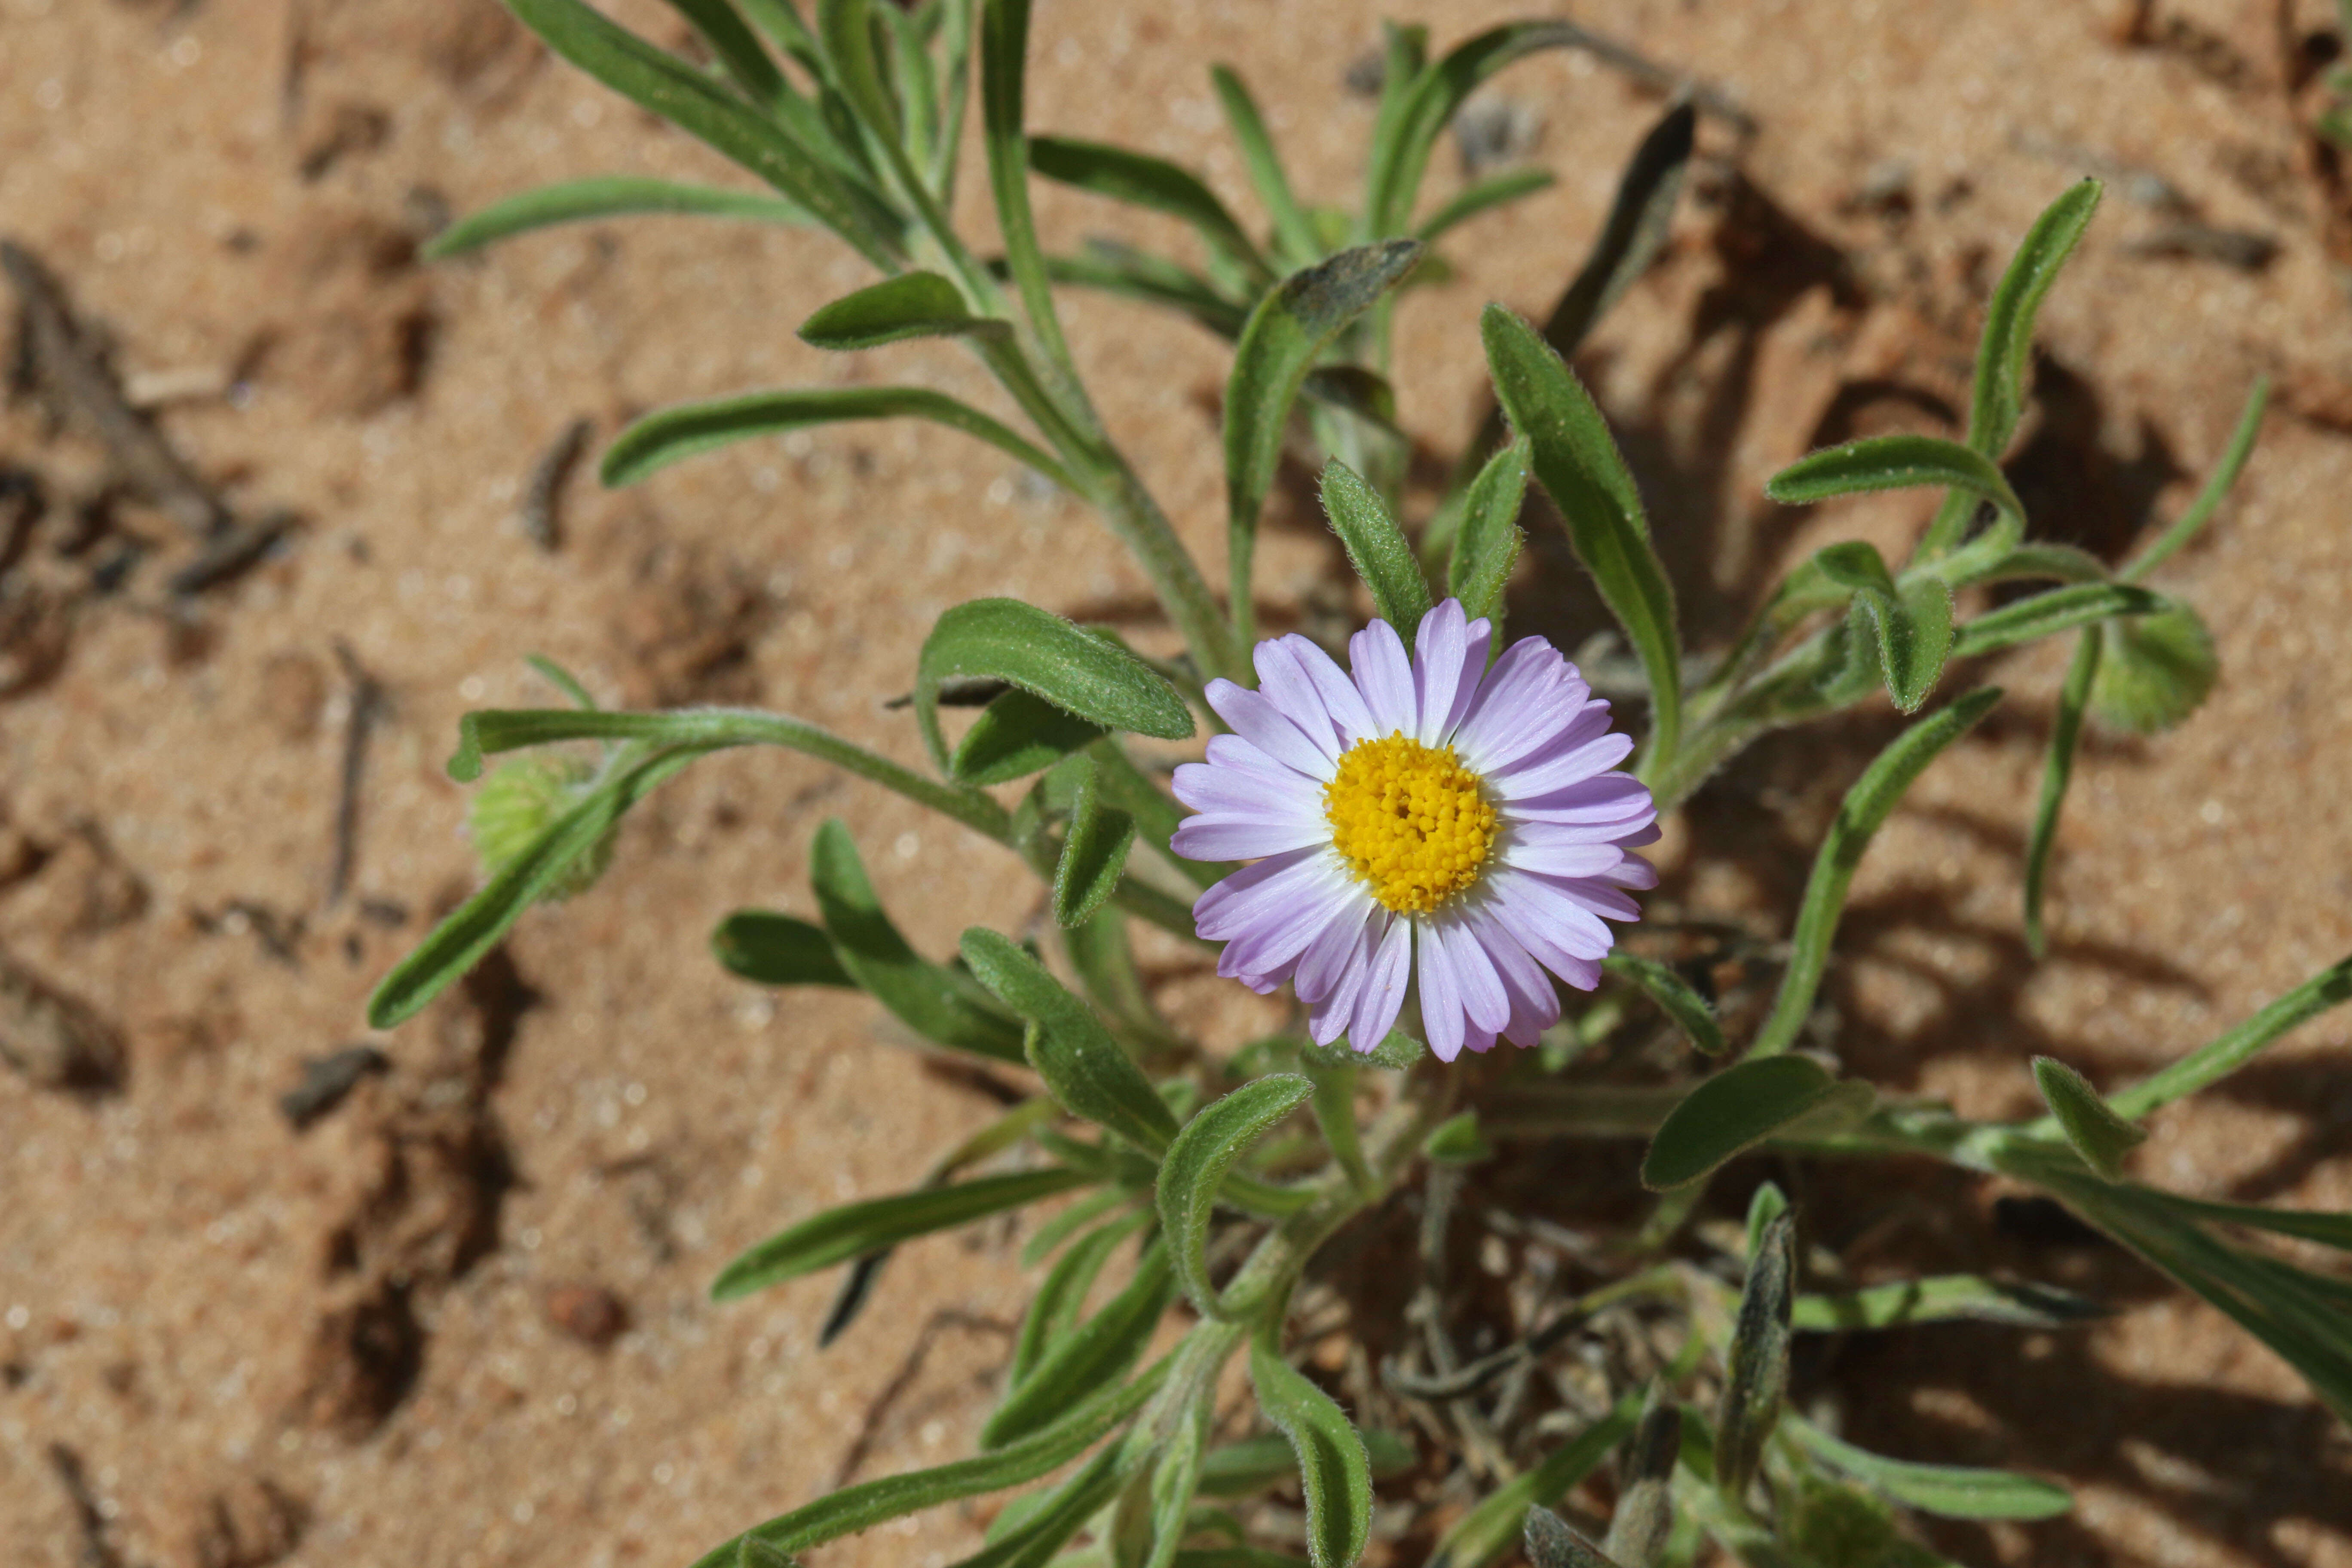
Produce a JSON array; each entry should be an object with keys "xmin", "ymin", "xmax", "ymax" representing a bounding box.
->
[{"xmin": 1324, "ymin": 731, "xmax": 1494, "ymax": 915}]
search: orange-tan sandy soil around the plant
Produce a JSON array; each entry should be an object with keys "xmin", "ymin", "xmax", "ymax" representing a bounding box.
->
[{"xmin": 0, "ymin": 0, "xmax": 2352, "ymax": 1568}]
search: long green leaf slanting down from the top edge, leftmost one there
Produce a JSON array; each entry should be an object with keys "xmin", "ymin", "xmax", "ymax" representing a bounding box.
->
[{"xmin": 508, "ymin": 0, "xmax": 898, "ymax": 270}]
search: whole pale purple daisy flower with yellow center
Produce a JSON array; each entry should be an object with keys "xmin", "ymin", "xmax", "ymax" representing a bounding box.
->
[{"xmin": 1174, "ymin": 600, "xmax": 1658, "ymax": 1063}]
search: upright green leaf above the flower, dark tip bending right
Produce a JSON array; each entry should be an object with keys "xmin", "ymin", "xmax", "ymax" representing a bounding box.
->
[{"xmin": 1225, "ymin": 240, "xmax": 1421, "ymax": 642}]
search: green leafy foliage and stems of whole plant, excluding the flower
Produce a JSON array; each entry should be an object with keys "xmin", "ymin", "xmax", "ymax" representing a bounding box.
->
[{"xmin": 369, "ymin": 12, "xmax": 2352, "ymax": 1568}]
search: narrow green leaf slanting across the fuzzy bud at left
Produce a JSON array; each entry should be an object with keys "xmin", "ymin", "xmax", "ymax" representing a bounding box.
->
[{"xmin": 367, "ymin": 747, "xmax": 713, "ymax": 1030}]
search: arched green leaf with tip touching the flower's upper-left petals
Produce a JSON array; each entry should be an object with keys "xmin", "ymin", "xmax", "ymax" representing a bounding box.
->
[{"xmin": 915, "ymin": 600, "xmax": 1192, "ymax": 769}]
